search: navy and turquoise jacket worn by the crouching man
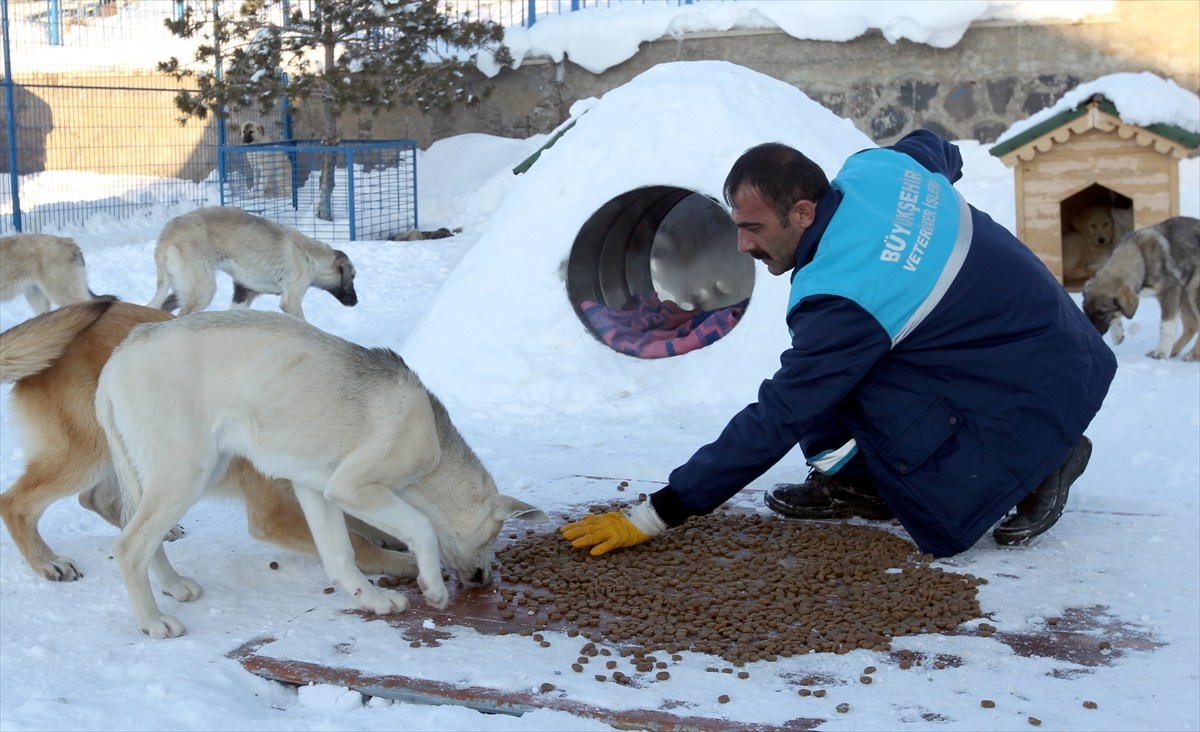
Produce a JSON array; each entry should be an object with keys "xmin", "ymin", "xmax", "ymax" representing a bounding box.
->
[{"xmin": 650, "ymin": 131, "xmax": 1116, "ymax": 556}]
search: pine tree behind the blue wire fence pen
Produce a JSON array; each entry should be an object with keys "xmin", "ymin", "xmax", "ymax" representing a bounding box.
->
[{"xmin": 158, "ymin": 0, "xmax": 511, "ymax": 221}]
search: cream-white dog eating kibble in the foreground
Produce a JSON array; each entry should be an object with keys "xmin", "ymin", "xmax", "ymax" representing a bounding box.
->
[{"xmin": 96, "ymin": 311, "xmax": 547, "ymax": 638}]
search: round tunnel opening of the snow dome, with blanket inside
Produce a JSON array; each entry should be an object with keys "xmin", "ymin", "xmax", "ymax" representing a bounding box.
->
[{"xmin": 566, "ymin": 186, "xmax": 754, "ymax": 358}]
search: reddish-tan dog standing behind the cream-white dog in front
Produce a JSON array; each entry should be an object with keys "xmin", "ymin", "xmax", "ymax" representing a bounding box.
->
[{"xmin": 0, "ymin": 299, "xmax": 416, "ymax": 582}]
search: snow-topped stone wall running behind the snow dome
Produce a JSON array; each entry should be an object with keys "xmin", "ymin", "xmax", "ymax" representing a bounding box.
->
[{"xmin": 333, "ymin": 0, "xmax": 1200, "ymax": 149}]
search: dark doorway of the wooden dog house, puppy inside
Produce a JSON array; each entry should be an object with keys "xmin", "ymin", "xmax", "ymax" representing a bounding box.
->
[{"xmin": 1058, "ymin": 184, "xmax": 1133, "ymax": 289}]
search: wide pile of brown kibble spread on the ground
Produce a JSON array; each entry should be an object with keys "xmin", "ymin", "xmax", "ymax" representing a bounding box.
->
[{"xmin": 497, "ymin": 505, "xmax": 986, "ymax": 665}]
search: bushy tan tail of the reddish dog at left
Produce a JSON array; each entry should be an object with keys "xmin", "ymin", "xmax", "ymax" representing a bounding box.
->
[{"xmin": 0, "ymin": 298, "xmax": 116, "ymax": 384}]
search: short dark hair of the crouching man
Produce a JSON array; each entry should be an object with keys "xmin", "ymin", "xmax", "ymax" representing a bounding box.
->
[{"xmin": 725, "ymin": 143, "xmax": 829, "ymax": 227}]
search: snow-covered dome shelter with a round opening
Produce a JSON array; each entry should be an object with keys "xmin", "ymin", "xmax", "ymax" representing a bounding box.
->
[{"xmin": 404, "ymin": 61, "xmax": 874, "ymax": 416}]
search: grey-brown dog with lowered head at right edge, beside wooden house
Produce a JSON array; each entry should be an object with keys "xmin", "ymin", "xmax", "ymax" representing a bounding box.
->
[{"xmin": 1084, "ymin": 216, "xmax": 1200, "ymax": 361}]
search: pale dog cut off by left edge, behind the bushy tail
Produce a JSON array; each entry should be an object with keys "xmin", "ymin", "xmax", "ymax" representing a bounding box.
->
[{"xmin": 0, "ymin": 234, "xmax": 96, "ymax": 314}]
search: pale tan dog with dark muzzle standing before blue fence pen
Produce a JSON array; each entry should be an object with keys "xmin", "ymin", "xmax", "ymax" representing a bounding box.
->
[{"xmin": 148, "ymin": 206, "xmax": 359, "ymax": 318}]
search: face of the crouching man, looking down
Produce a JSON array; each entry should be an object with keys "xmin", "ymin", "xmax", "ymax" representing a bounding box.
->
[{"xmin": 731, "ymin": 187, "xmax": 816, "ymax": 275}]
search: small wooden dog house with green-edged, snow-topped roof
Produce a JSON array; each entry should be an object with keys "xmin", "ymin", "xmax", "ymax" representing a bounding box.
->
[{"xmin": 990, "ymin": 95, "xmax": 1200, "ymax": 288}]
